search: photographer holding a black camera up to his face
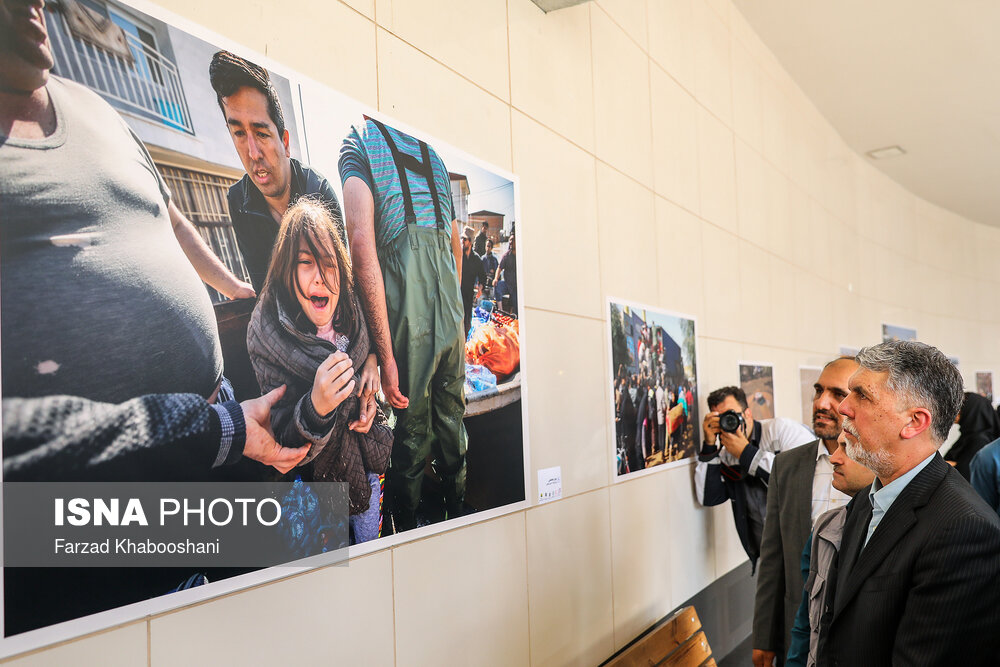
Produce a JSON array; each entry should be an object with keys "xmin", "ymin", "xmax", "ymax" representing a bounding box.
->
[{"xmin": 694, "ymin": 387, "xmax": 816, "ymax": 570}]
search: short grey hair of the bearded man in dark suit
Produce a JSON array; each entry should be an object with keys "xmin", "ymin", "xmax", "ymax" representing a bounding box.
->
[{"xmin": 855, "ymin": 340, "xmax": 965, "ymax": 445}]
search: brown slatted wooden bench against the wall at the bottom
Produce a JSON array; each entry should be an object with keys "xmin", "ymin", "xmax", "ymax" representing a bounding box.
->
[{"xmin": 604, "ymin": 607, "xmax": 715, "ymax": 667}]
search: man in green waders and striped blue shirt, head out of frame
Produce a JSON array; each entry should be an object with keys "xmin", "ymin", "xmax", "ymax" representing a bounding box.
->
[{"xmin": 340, "ymin": 118, "xmax": 467, "ymax": 532}]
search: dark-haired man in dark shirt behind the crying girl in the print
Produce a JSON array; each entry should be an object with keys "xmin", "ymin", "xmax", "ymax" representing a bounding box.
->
[{"xmin": 208, "ymin": 51, "xmax": 346, "ymax": 292}]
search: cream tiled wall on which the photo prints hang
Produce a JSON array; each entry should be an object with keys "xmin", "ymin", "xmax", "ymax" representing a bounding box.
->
[{"xmin": 14, "ymin": 0, "xmax": 1000, "ymax": 667}]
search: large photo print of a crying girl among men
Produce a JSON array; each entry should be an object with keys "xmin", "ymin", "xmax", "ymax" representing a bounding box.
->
[{"xmin": 0, "ymin": 0, "xmax": 527, "ymax": 648}]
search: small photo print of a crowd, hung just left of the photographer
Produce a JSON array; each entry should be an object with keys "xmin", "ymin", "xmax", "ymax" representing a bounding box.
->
[{"xmin": 610, "ymin": 301, "xmax": 700, "ymax": 475}]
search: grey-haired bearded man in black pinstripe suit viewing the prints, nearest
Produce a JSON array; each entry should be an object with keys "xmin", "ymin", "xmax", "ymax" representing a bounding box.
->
[{"xmin": 818, "ymin": 341, "xmax": 1000, "ymax": 667}]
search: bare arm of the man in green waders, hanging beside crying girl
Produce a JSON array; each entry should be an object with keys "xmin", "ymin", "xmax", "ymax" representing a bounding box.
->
[{"xmin": 344, "ymin": 176, "xmax": 409, "ymax": 408}]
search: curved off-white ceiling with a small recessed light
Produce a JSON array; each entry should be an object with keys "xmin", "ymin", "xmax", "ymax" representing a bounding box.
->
[{"xmin": 734, "ymin": 0, "xmax": 1000, "ymax": 226}]
